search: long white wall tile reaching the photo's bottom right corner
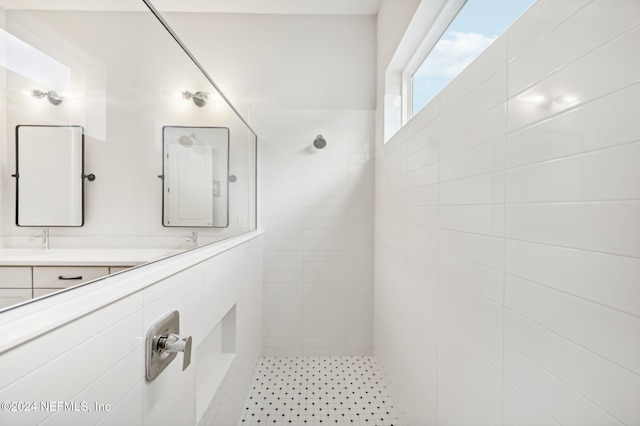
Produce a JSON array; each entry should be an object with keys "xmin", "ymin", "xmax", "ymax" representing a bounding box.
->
[{"xmin": 505, "ymin": 310, "xmax": 640, "ymax": 424}]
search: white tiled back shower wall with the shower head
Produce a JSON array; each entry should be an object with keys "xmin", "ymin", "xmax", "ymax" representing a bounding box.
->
[{"xmin": 255, "ymin": 109, "xmax": 373, "ymax": 356}]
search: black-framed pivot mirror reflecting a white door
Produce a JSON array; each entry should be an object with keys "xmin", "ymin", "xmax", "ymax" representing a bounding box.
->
[{"xmin": 160, "ymin": 126, "xmax": 229, "ymax": 228}]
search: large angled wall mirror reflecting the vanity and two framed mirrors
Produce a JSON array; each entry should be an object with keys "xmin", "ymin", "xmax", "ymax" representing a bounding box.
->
[{"xmin": 0, "ymin": 0, "xmax": 257, "ymax": 309}]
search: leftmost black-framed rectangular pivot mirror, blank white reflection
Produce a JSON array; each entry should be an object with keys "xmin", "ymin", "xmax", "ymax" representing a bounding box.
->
[{"xmin": 13, "ymin": 125, "xmax": 84, "ymax": 227}]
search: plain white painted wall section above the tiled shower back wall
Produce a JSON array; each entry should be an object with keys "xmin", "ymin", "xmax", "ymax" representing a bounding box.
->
[{"xmin": 157, "ymin": 13, "xmax": 376, "ymax": 115}]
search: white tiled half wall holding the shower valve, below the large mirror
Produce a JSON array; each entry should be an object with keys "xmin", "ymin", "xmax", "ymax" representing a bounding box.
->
[{"xmin": 0, "ymin": 236, "xmax": 263, "ymax": 425}]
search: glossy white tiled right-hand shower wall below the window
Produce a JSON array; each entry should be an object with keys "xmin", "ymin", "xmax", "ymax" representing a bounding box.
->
[{"xmin": 374, "ymin": 0, "xmax": 640, "ymax": 425}]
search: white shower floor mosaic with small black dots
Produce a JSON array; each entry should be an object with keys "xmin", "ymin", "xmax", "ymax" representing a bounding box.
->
[{"xmin": 240, "ymin": 356, "xmax": 398, "ymax": 426}]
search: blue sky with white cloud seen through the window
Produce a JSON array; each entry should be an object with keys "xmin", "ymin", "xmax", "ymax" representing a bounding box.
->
[{"xmin": 412, "ymin": 0, "xmax": 536, "ymax": 114}]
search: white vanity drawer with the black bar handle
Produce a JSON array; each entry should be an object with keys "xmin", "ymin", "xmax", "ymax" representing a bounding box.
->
[{"xmin": 33, "ymin": 266, "xmax": 109, "ymax": 288}]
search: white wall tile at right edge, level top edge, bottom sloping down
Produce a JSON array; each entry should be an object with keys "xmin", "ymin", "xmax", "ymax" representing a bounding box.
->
[{"xmin": 507, "ymin": 202, "xmax": 640, "ymax": 257}]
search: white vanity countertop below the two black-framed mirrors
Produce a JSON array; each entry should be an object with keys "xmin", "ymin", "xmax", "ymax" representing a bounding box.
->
[{"xmin": 0, "ymin": 249, "xmax": 184, "ymax": 266}]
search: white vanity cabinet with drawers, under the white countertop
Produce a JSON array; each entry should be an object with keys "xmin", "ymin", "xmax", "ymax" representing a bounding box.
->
[{"xmin": 0, "ymin": 265, "xmax": 131, "ymax": 309}]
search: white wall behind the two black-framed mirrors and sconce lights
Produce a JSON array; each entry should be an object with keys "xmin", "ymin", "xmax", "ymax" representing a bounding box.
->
[{"xmin": 0, "ymin": 10, "xmax": 255, "ymax": 248}]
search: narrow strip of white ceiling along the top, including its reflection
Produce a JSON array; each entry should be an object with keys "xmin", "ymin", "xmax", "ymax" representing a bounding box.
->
[{"xmin": 0, "ymin": 0, "xmax": 381, "ymax": 15}]
